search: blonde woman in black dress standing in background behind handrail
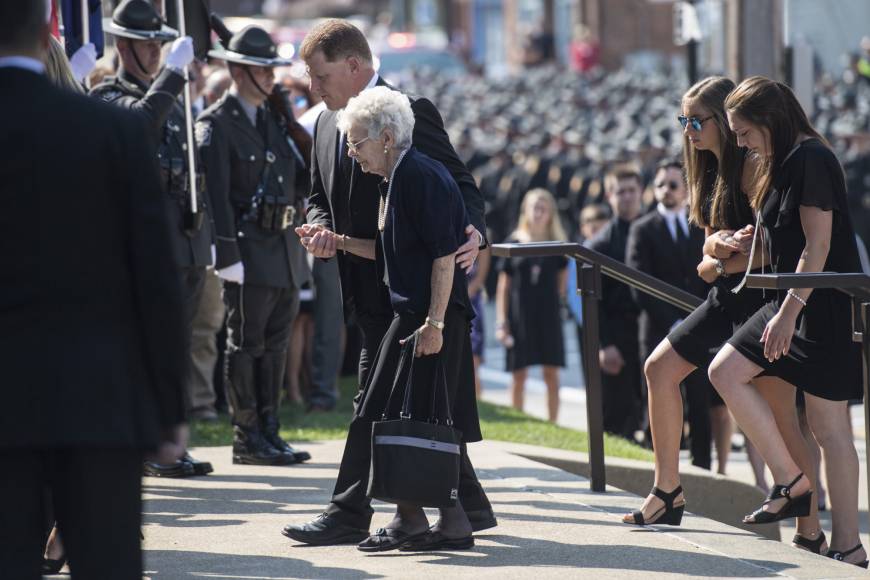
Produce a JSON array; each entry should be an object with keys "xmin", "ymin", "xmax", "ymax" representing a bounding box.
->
[{"xmin": 495, "ymin": 189, "xmax": 568, "ymax": 423}]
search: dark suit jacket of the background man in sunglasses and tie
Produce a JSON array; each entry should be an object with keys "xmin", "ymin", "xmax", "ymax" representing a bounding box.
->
[{"xmin": 626, "ymin": 210, "xmax": 709, "ymax": 356}]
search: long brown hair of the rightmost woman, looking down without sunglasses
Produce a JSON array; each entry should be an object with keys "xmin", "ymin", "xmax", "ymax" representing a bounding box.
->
[{"xmin": 725, "ymin": 76, "xmax": 830, "ymax": 211}]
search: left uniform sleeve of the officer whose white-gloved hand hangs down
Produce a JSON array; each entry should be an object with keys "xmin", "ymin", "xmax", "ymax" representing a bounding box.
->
[{"xmin": 196, "ymin": 117, "xmax": 242, "ymax": 270}]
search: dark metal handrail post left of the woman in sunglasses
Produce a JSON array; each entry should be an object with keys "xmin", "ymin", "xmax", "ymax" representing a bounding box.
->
[{"xmin": 577, "ymin": 260, "xmax": 607, "ymax": 491}]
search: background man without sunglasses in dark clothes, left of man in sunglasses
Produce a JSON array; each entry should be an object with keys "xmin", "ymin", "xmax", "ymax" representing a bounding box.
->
[{"xmin": 586, "ymin": 166, "xmax": 643, "ymax": 439}]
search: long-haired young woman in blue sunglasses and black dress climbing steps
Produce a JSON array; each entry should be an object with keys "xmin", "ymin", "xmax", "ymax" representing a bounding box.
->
[{"xmin": 624, "ymin": 77, "xmax": 825, "ymax": 553}]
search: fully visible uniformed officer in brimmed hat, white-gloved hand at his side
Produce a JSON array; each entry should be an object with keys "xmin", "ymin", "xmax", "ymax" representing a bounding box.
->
[{"xmin": 196, "ymin": 26, "xmax": 310, "ymax": 465}]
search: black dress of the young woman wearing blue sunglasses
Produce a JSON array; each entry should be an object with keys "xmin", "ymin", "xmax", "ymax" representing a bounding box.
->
[{"xmin": 668, "ymin": 172, "xmax": 765, "ymax": 370}]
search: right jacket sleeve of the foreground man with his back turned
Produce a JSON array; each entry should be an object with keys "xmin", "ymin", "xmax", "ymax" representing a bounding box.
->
[{"xmin": 118, "ymin": 115, "xmax": 190, "ymax": 429}]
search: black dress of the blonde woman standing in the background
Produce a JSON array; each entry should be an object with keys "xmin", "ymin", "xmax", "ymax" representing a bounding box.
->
[{"xmin": 499, "ymin": 239, "xmax": 568, "ymax": 371}]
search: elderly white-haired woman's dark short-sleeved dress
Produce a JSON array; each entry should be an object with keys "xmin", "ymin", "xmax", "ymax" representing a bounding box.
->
[{"xmin": 357, "ymin": 147, "xmax": 482, "ymax": 448}]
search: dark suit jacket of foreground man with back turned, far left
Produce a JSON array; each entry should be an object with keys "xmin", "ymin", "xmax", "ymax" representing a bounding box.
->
[{"xmin": 0, "ymin": 68, "xmax": 188, "ymax": 448}]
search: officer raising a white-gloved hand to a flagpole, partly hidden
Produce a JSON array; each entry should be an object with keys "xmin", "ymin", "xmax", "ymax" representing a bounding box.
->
[{"xmin": 91, "ymin": 0, "xmax": 212, "ymax": 477}]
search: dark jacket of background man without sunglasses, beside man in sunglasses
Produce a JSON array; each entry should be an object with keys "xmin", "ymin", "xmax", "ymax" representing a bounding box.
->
[{"xmin": 586, "ymin": 217, "xmax": 639, "ymax": 357}]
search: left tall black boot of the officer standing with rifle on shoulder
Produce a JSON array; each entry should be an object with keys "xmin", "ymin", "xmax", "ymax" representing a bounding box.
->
[{"xmin": 226, "ymin": 351, "xmax": 287, "ymax": 465}]
